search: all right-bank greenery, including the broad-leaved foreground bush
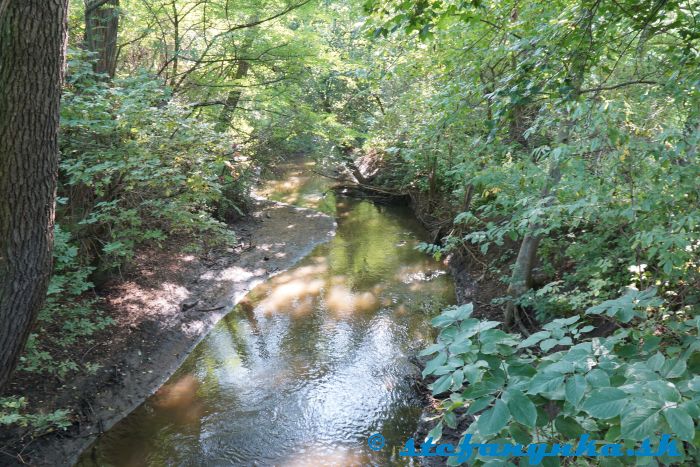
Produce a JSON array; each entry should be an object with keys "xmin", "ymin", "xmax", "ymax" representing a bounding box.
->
[{"xmin": 358, "ymin": 0, "xmax": 700, "ymax": 465}]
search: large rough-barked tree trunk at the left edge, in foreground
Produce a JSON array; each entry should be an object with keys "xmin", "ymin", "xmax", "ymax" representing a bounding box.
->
[{"xmin": 0, "ymin": 0, "xmax": 68, "ymax": 392}]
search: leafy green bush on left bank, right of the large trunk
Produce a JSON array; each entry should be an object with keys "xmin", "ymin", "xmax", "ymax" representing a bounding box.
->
[{"xmin": 59, "ymin": 52, "xmax": 239, "ymax": 268}]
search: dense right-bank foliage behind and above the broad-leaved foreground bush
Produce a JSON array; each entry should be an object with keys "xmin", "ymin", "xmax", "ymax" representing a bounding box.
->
[{"xmin": 368, "ymin": 1, "xmax": 700, "ymax": 320}]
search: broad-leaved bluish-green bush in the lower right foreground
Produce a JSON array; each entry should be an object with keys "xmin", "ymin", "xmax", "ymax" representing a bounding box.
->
[{"xmin": 422, "ymin": 290, "xmax": 700, "ymax": 465}]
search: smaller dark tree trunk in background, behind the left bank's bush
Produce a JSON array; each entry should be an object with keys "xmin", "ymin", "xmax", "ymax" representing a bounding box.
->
[{"xmin": 85, "ymin": 0, "xmax": 119, "ymax": 78}]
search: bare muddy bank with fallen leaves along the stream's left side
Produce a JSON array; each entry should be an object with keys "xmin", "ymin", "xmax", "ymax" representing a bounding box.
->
[{"xmin": 0, "ymin": 199, "xmax": 335, "ymax": 466}]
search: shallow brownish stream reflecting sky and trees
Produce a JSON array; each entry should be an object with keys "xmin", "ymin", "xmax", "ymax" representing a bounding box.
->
[{"xmin": 77, "ymin": 160, "xmax": 454, "ymax": 466}]
